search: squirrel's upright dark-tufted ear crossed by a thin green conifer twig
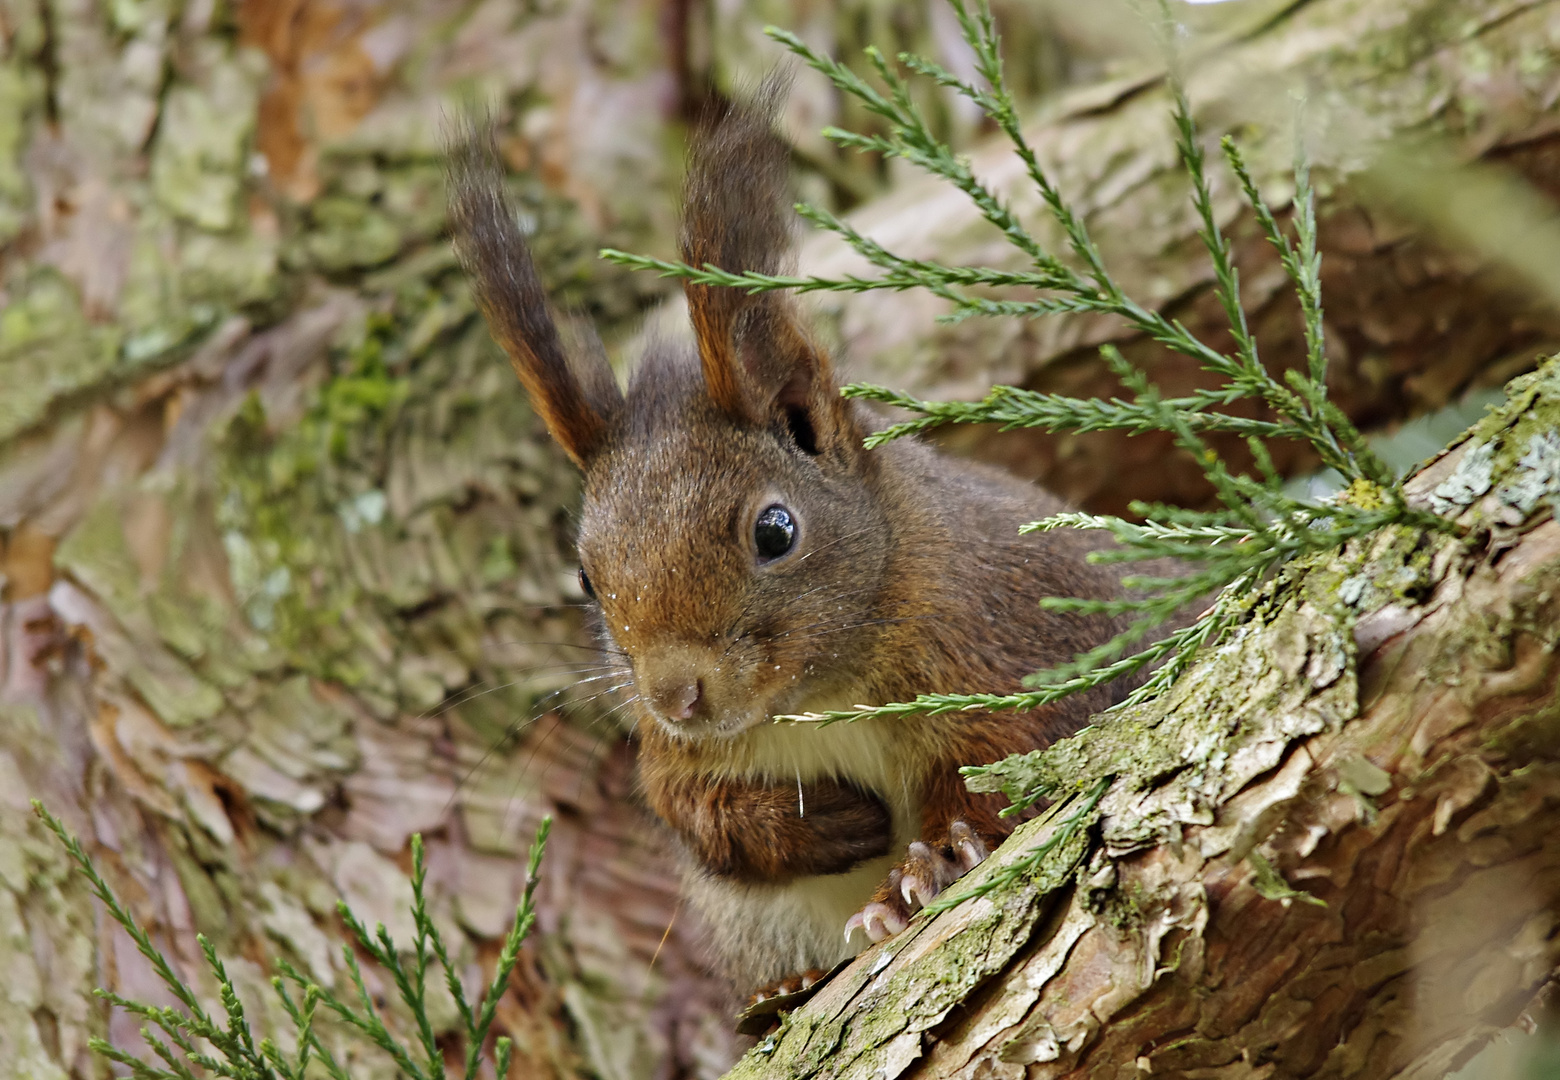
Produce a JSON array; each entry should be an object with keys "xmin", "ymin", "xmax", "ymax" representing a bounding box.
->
[{"xmin": 680, "ymin": 69, "xmax": 835, "ymax": 423}]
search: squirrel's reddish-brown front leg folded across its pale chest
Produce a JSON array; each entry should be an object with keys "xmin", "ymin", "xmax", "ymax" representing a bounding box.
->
[{"xmin": 646, "ymin": 774, "xmax": 892, "ymax": 885}]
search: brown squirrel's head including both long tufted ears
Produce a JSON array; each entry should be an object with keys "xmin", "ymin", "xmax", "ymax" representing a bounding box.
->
[{"xmin": 451, "ymin": 76, "xmax": 895, "ymax": 740}]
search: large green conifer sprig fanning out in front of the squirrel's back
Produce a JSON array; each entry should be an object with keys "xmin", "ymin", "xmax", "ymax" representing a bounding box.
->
[{"xmin": 604, "ymin": 0, "xmax": 1449, "ymax": 723}]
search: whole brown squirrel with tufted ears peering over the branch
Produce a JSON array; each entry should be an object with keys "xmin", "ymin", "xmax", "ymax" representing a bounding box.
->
[{"xmin": 449, "ymin": 78, "xmax": 1119, "ymax": 1011}]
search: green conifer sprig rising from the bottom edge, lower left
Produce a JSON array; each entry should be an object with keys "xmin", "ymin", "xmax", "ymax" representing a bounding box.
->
[{"xmin": 33, "ymin": 801, "xmax": 552, "ymax": 1080}]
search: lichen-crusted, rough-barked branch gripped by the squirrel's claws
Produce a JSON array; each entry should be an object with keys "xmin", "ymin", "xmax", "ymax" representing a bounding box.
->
[{"xmin": 732, "ymin": 362, "xmax": 1560, "ymax": 1080}]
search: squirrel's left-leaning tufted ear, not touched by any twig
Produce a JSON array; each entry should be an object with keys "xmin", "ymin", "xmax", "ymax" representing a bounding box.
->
[{"xmin": 449, "ymin": 117, "xmax": 622, "ymax": 467}]
